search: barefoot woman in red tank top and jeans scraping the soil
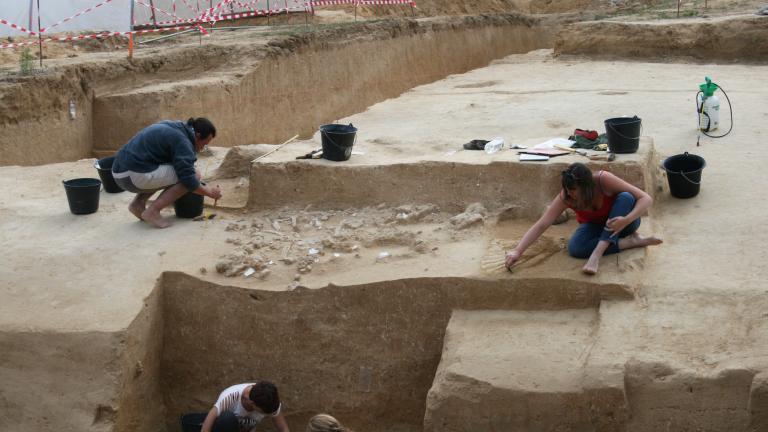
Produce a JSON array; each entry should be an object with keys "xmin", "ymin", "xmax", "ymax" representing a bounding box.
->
[{"xmin": 505, "ymin": 163, "xmax": 662, "ymax": 275}]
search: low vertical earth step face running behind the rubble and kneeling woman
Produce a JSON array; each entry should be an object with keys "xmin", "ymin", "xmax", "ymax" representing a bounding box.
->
[{"xmin": 248, "ymin": 145, "xmax": 660, "ymax": 218}]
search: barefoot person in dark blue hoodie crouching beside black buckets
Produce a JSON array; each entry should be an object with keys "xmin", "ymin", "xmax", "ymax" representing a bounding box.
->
[{"xmin": 112, "ymin": 117, "xmax": 221, "ymax": 228}]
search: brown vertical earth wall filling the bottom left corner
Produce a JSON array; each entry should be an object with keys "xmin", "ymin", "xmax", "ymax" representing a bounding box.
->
[{"xmin": 0, "ymin": 331, "xmax": 122, "ymax": 432}]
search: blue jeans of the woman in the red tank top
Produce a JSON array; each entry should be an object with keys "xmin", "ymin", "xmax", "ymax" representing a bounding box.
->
[{"xmin": 568, "ymin": 192, "xmax": 640, "ymax": 258}]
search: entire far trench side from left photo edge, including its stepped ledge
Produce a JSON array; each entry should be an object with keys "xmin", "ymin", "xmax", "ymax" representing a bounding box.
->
[{"xmin": 0, "ymin": 14, "xmax": 553, "ymax": 165}]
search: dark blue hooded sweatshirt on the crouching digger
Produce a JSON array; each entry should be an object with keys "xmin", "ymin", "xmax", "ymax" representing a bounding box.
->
[{"xmin": 112, "ymin": 120, "xmax": 200, "ymax": 191}]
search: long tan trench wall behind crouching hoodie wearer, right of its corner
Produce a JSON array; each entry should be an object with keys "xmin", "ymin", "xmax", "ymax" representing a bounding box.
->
[{"xmin": 94, "ymin": 17, "xmax": 548, "ymax": 155}]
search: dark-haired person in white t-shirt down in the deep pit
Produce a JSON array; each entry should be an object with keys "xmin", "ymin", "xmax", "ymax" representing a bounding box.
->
[{"xmin": 202, "ymin": 381, "xmax": 289, "ymax": 432}]
